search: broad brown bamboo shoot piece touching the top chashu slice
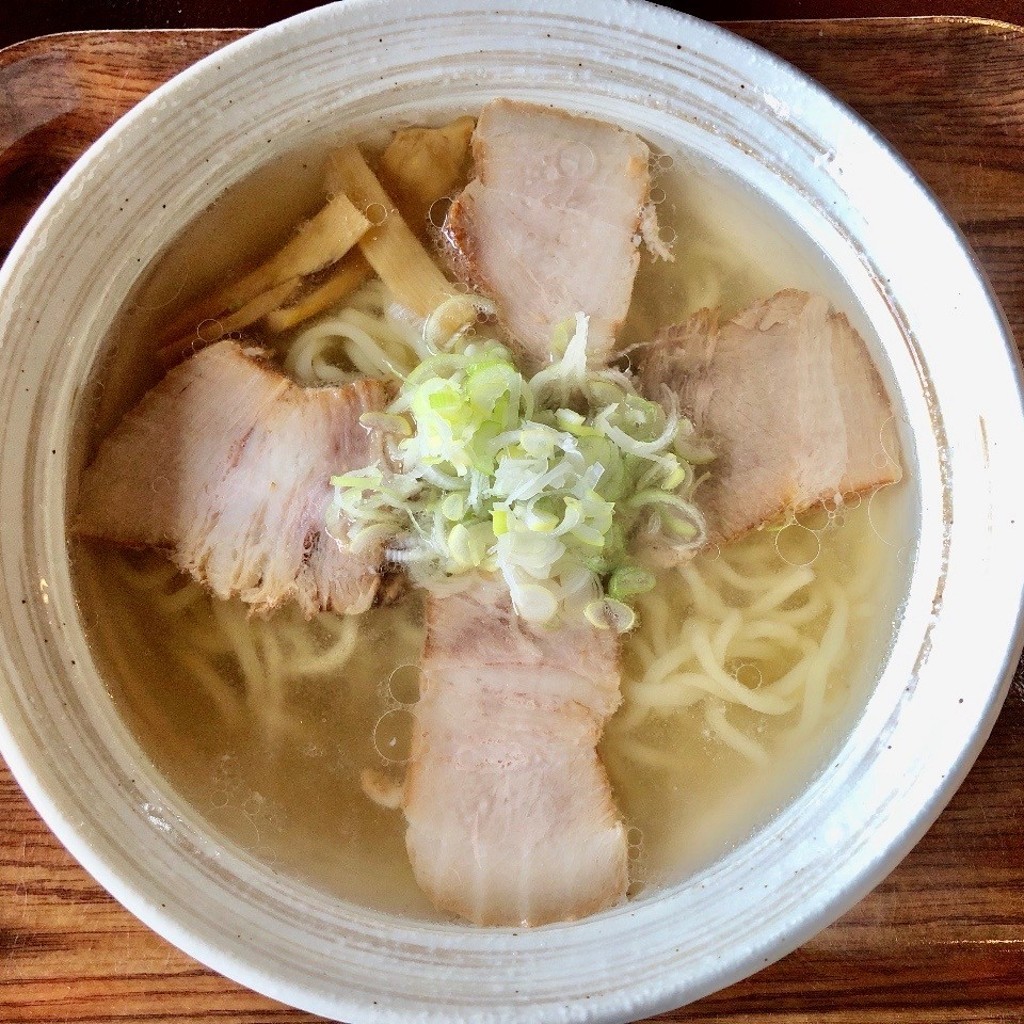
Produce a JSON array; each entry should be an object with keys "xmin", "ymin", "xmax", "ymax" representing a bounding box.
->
[{"xmin": 380, "ymin": 117, "xmax": 476, "ymax": 237}]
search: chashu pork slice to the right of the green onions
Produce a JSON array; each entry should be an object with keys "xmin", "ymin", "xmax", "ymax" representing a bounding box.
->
[{"xmin": 641, "ymin": 289, "xmax": 900, "ymax": 543}]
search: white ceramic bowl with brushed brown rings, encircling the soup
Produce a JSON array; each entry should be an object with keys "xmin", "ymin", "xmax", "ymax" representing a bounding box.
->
[{"xmin": 0, "ymin": 0, "xmax": 1024, "ymax": 1024}]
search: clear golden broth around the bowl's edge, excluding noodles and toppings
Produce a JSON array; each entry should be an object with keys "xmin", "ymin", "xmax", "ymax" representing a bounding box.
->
[{"xmin": 73, "ymin": 125, "xmax": 910, "ymax": 918}]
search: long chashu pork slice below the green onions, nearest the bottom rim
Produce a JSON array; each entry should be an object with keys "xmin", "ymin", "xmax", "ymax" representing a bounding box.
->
[{"xmin": 403, "ymin": 583, "xmax": 628, "ymax": 926}]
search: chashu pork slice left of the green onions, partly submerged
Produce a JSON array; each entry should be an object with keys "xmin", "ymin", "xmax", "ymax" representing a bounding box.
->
[{"xmin": 74, "ymin": 341, "xmax": 389, "ymax": 614}]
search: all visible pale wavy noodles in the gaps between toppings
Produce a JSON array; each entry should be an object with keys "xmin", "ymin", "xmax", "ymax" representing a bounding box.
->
[{"xmin": 99, "ymin": 274, "xmax": 887, "ymax": 880}]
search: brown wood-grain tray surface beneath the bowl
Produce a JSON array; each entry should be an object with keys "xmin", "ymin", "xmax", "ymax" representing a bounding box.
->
[{"xmin": 0, "ymin": 18, "xmax": 1024, "ymax": 1024}]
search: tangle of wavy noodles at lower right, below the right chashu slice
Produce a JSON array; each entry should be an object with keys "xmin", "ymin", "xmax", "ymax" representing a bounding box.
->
[{"xmin": 604, "ymin": 495, "xmax": 885, "ymax": 776}]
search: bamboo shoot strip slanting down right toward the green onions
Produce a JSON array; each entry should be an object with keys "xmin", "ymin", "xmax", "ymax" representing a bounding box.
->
[{"xmin": 327, "ymin": 145, "xmax": 456, "ymax": 316}]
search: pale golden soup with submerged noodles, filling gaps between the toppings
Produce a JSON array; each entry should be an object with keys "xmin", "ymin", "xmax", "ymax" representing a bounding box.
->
[{"xmin": 74, "ymin": 103, "xmax": 908, "ymax": 918}]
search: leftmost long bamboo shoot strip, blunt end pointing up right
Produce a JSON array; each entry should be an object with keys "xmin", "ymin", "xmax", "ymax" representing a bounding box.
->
[{"xmin": 155, "ymin": 195, "xmax": 370, "ymax": 361}]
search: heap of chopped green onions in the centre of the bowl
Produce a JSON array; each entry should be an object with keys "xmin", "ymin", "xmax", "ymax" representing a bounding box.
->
[{"xmin": 327, "ymin": 309, "xmax": 710, "ymax": 632}]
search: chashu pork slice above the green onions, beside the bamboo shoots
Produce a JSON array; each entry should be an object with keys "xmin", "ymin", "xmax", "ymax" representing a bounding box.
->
[{"xmin": 444, "ymin": 99, "xmax": 650, "ymax": 369}]
